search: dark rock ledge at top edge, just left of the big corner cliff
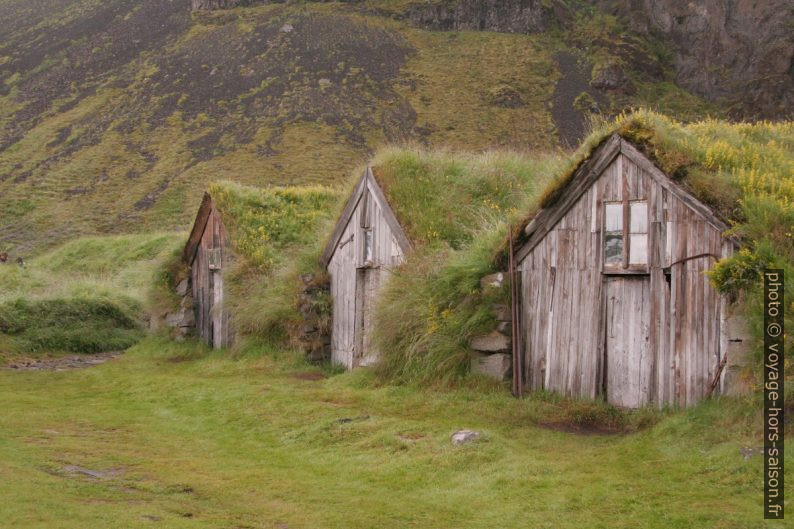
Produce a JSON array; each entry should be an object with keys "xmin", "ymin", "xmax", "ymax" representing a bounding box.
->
[{"xmin": 405, "ymin": 0, "xmax": 567, "ymax": 33}]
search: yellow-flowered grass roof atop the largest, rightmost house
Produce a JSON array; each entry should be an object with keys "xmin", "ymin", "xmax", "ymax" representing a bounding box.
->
[{"xmin": 512, "ymin": 111, "xmax": 794, "ymax": 255}]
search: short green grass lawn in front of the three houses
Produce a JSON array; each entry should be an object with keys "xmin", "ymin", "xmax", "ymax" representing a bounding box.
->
[{"xmin": 0, "ymin": 338, "xmax": 794, "ymax": 529}]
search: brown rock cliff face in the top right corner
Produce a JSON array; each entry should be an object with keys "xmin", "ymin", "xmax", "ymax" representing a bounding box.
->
[{"xmin": 590, "ymin": 0, "xmax": 794, "ymax": 119}]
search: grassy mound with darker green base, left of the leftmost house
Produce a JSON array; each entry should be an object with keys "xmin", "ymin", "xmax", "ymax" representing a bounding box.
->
[{"xmin": 0, "ymin": 233, "xmax": 183, "ymax": 354}]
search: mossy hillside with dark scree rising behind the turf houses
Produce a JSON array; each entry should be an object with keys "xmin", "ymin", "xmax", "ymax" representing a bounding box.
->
[{"xmin": 0, "ymin": 0, "xmax": 744, "ymax": 256}]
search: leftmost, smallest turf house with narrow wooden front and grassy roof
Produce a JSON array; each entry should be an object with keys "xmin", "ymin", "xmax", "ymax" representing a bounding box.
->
[{"xmin": 179, "ymin": 182, "xmax": 337, "ymax": 347}]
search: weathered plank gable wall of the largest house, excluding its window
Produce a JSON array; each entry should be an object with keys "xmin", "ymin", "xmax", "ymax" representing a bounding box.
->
[{"xmin": 519, "ymin": 144, "xmax": 734, "ymax": 406}]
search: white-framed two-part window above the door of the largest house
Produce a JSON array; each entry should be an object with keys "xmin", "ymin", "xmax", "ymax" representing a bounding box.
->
[{"xmin": 603, "ymin": 200, "xmax": 648, "ymax": 273}]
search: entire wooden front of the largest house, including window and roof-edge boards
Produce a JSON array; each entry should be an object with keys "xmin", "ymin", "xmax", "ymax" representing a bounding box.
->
[{"xmin": 516, "ymin": 133, "xmax": 738, "ymax": 408}]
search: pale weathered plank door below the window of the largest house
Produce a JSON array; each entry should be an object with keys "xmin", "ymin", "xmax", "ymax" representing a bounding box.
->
[{"xmin": 605, "ymin": 275, "xmax": 653, "ymax": 408}]
